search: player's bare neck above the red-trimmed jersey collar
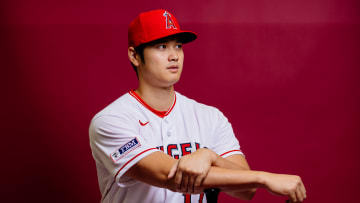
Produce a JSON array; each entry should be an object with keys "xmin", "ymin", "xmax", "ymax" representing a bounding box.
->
[{"xmin": 135, "ymin": 85, "xmax": 174, "ymax": 111}]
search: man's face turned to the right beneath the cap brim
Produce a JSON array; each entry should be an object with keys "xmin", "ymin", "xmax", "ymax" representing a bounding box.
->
[{"xmin": 138, "ymin": 38, "xmax": 184, "ymax": 87}]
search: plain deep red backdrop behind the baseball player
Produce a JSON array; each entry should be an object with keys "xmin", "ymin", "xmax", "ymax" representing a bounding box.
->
[{"xmin": 0, "ymin": 0, "xmax": 360, "ymax": 203}]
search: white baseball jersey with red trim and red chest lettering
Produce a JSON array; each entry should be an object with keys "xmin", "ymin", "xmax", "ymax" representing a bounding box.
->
[{"xmin": 89, "ymin": 91, "xmax": 242, "ymax": 203}]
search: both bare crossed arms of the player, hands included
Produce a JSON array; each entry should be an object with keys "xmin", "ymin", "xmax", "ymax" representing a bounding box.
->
[{"xmin": 126, "ymin": 149, "xmax": 306, "ymax": 202}]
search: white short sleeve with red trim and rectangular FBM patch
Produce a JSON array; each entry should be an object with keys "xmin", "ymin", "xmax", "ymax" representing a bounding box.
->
[{"xmin": 89, "ymin": 115, "xmax": 158, "ymax": 187}]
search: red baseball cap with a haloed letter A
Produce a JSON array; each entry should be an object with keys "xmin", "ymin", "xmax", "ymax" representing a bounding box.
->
[{"xmin": 129, "ymin": 9, "xmax": 197, "ymax": 47}]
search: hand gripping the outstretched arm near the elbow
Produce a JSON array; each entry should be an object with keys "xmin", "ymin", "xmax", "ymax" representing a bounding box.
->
[{"xmin": 168, "ymin": 148, "xmax": 216, "ymax": 193}]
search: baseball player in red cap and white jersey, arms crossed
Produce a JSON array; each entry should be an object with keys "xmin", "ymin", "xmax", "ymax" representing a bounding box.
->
[{"xmin": 89, "ymin": 10, "xmax": 306, "ymax": 203}]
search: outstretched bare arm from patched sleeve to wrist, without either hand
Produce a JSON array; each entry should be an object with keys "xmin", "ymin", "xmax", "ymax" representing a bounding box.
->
[{"xmin": 126, "ymin": 152, "xmax": 259, "ymax": 191}]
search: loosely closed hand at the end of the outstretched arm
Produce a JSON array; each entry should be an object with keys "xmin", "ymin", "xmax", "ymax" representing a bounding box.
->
[{"xmin": 264, "ymin": 172, "xmax": 306, "ymax": 202}]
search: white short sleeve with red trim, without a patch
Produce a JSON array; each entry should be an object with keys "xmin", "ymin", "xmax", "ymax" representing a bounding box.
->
[{"xmin": 211, "ymin": 109, "xmax": 244, "ymax": 158}]
